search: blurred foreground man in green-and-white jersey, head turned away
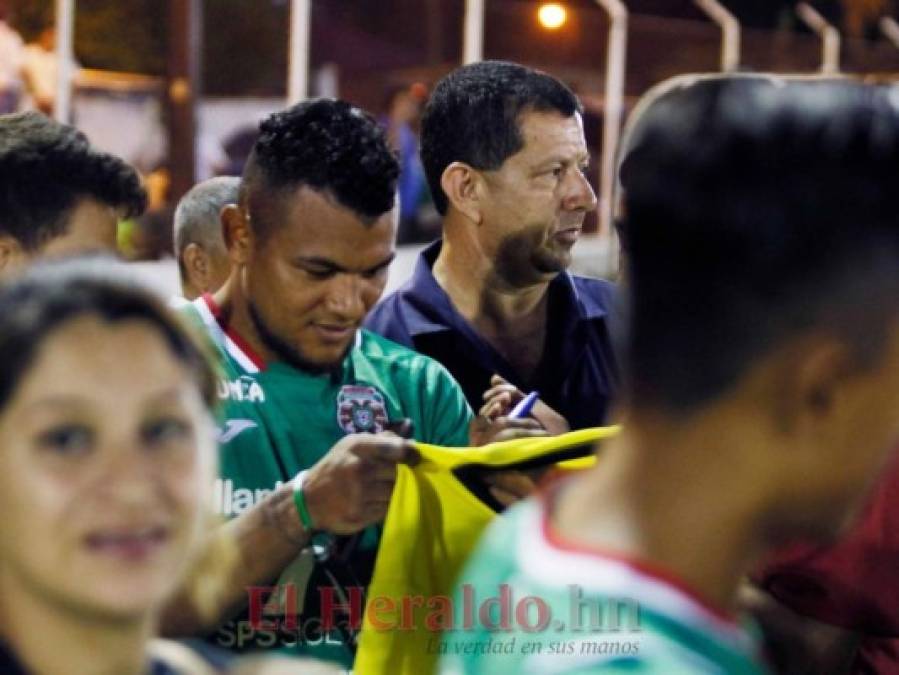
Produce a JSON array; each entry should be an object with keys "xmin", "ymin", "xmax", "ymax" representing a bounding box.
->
[{"xmin": 442, "ymin": 78, "xmax": 899, "ymax": 675}]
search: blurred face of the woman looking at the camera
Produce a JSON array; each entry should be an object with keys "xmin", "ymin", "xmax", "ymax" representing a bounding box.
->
[{"xmin": 0, "ymin": 316, "xmax": 213, "ymax": 618}]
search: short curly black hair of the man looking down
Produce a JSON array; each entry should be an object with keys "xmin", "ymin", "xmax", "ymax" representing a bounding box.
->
[{"xmin": 241, "ymin": 98, "xmax": 400, "ymax": 236}]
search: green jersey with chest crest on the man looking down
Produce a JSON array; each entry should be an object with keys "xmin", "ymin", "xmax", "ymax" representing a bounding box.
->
[{"xmin": 182, "ymin": 296, "xmax": 472, "ymax": 665}]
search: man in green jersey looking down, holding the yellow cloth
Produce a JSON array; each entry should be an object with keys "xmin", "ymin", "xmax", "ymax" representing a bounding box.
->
[{"xmin": 165, "ymin": 99, "xmax": 541, "ymax": 664}]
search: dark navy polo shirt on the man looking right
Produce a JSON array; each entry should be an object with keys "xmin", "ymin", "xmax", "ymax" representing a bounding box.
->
[{"xmin": 366, "ymin": 241, "xmax": 618, "ymax": 429}]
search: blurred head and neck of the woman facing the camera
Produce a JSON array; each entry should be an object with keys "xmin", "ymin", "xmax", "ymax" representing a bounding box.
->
[{"xmin": 0, "ymin": 262, "xmax": 215, "ymax": 672}]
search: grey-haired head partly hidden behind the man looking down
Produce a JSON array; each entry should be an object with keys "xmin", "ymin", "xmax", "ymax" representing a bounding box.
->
[{"xmin": 174, "ymin": 176, "xmax": 240, "ymax": 300}]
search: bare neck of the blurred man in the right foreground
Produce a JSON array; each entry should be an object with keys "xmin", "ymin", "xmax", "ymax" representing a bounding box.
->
[{"xmin": 551, "ymin": 420, "xmax": 766, "ymax": 611}]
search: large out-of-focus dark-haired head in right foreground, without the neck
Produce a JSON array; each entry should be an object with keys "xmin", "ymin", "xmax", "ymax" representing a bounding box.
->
[{"xmin": 620, "ymin": 78, "xmax": 899, "ymax": 534}]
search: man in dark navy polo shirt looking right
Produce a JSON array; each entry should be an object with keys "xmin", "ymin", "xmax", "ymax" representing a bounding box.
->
[{"xmin": 367, "ymin": 61, "xmax": 617, "ymax": 428}]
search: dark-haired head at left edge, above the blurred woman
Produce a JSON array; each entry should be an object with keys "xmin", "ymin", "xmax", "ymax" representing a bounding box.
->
[{"xmin": 0, "ymin": 113, "xmax": 147, "ymax": 276}]
